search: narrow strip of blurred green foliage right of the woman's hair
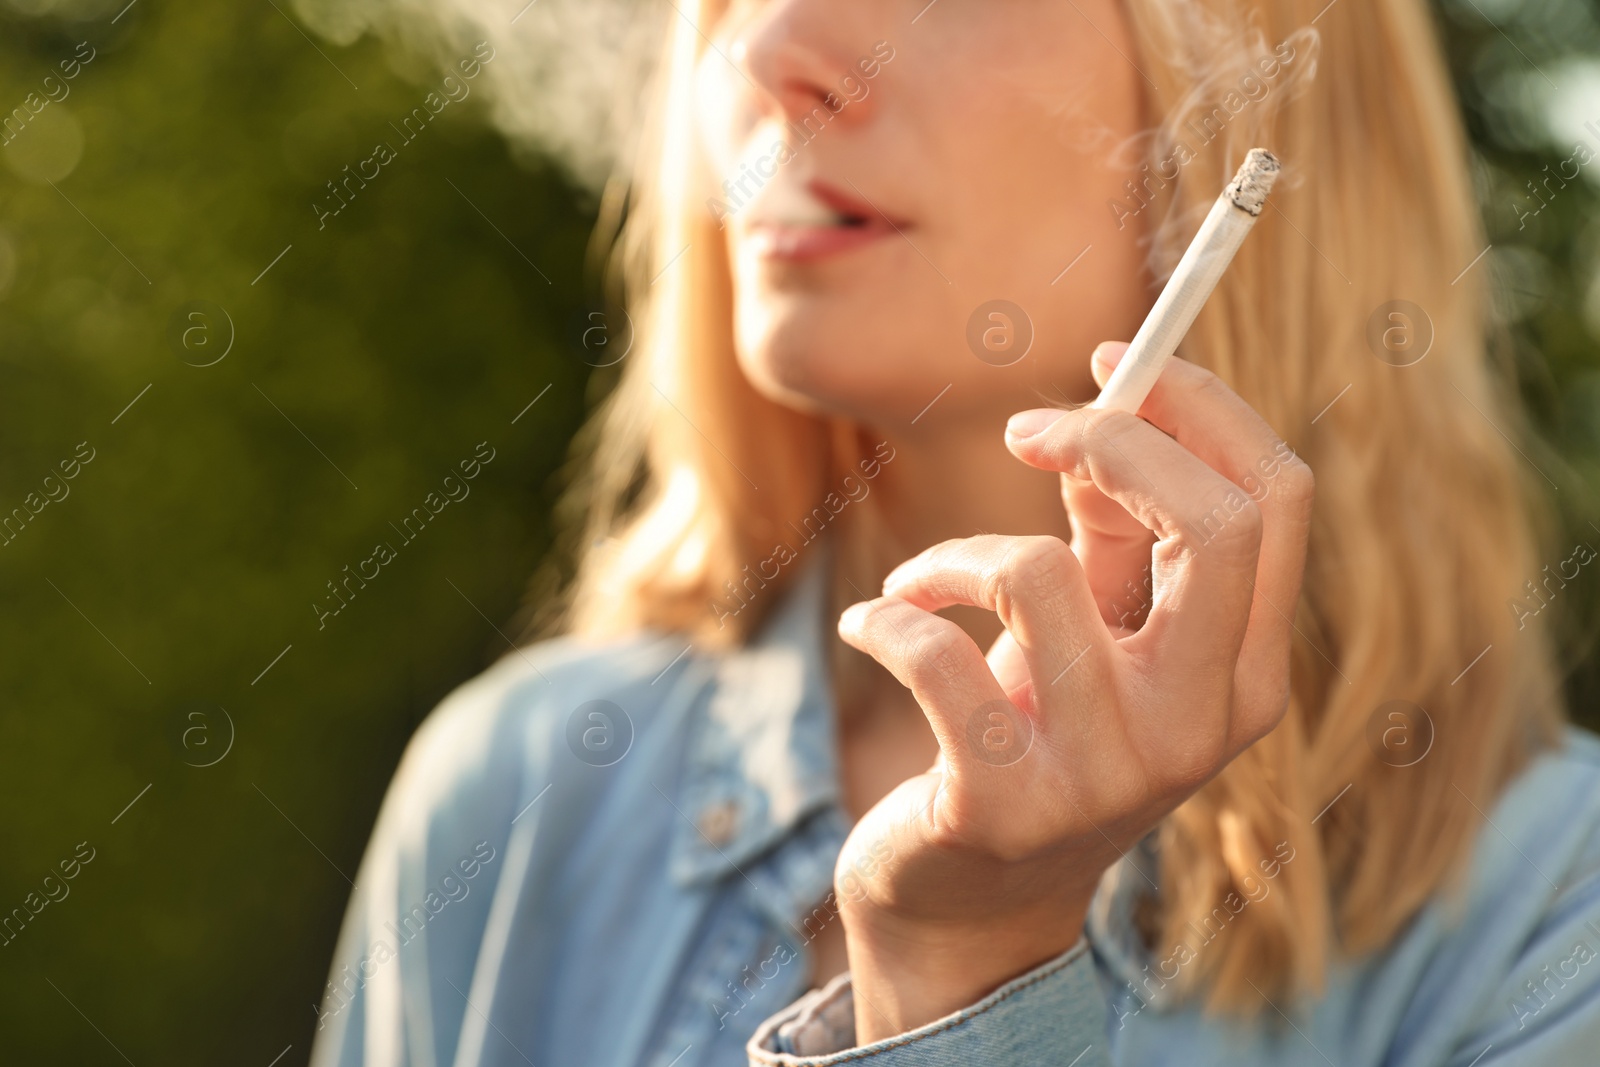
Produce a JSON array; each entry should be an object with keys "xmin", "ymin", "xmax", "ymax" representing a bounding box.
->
[{"xmin": 1437, "ymin": 0, "xmax": 1600, "ymax": 716}]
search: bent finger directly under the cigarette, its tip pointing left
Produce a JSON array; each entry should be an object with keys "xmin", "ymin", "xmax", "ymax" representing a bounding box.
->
[{"xmin": 1006, "ymin": 376, "xmax": 1262, "ymax": 702}]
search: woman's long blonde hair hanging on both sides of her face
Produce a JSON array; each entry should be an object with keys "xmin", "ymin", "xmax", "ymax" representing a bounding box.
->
[{"xmin": 550, "ymin": 0, "xmax": 1562, "ymax": 1013}]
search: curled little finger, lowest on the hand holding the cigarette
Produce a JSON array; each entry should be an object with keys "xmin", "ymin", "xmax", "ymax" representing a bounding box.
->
[{"xmin": 838, "ymin": 597, "xmax": 1010, "ymax": 766}]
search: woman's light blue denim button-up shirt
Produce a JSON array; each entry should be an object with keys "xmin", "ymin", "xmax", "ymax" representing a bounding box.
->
[{"xmin": 312, "ymin": 566, "xmax": 1600, "ymax": 1067}]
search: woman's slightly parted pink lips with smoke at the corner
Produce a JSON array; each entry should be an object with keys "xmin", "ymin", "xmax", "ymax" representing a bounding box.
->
[{"xmin": 746, "ymin": 179, "xmax": 904, "ymax": 262}]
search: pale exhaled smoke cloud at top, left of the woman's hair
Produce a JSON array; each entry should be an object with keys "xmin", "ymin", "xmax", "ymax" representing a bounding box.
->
[{"xmin": 294, "ymin": 0, "xmax": 670, "ymax": 189}]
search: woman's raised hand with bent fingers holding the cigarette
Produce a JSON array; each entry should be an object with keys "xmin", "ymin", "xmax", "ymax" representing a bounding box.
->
[{"xmin": 835, "ymin": 346, "xmax": 1312, "ymax": 1045}]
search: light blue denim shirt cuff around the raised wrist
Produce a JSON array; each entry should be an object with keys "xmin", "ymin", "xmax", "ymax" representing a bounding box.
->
[{"xmin": 746, "ymin": 939, "xmax": 1110, "ymax": 1067}]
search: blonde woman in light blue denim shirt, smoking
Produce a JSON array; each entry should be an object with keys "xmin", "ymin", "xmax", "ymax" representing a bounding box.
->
[{"xmin": 305, "ymin": 0, "xmax": 1600, "ymax": 1067}]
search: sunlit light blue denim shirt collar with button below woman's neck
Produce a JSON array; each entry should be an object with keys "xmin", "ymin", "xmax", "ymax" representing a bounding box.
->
[{"xmin": 672, "ymin": 550, "xmax": 840, "ymax": 885}]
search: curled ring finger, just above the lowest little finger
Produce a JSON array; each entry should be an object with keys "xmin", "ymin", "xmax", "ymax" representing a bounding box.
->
[{"xmin": 883, "ymin": 534, "xmax": 1112, "ymax": 709}]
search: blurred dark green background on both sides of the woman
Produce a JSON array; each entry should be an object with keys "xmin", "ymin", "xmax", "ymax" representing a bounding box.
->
[{"xmin": 0, "ymin": 0, "xmax": 1600, "ymax": 1067}]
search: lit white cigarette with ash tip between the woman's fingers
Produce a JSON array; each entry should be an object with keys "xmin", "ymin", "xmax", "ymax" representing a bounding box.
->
[{"xmin": 1090, "ymin": 149, "xmax": 1280, "ymax": 413}]
